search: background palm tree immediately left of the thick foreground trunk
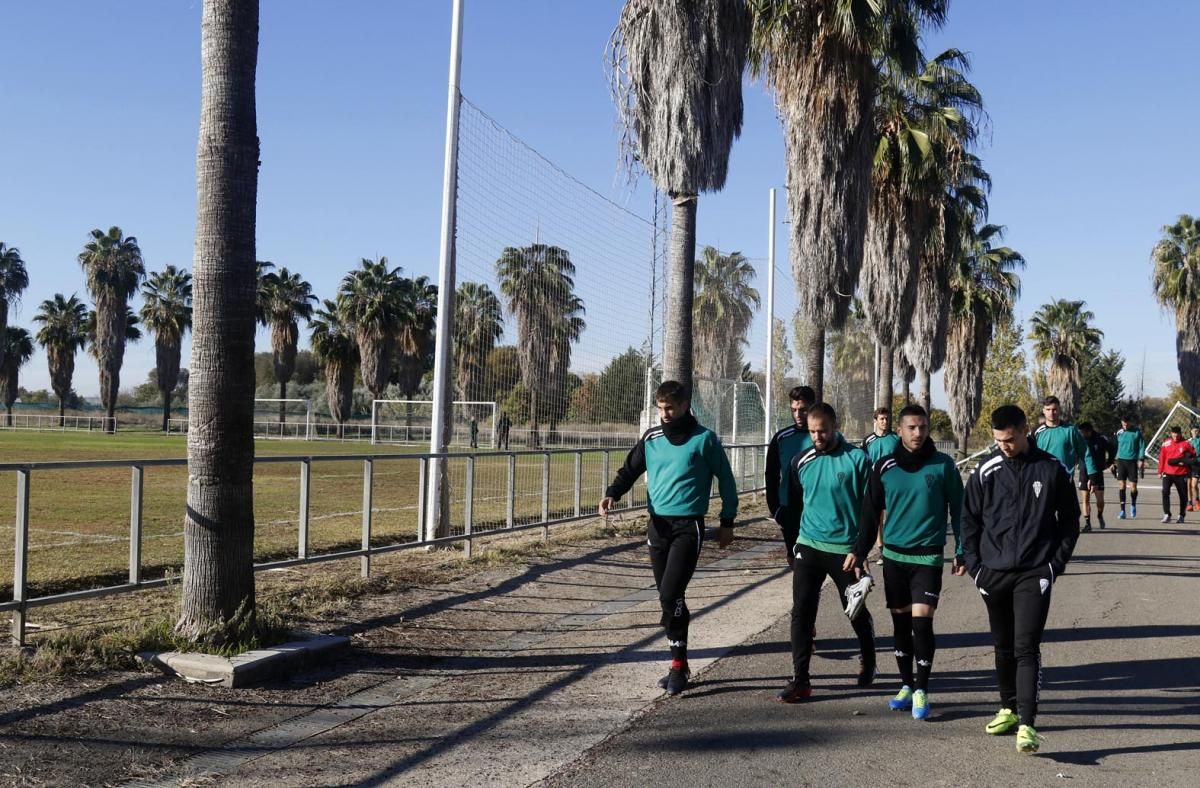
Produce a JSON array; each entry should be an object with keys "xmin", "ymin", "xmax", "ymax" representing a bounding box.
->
[{"xmin": 140, "ymin": 265, "xmax": 192, "ymax": 432}]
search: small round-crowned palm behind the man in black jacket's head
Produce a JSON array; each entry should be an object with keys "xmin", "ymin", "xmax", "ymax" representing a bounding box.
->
[{"xmin": 1030, "ymin": 299, "xmax": 1104, "ymax": 420}]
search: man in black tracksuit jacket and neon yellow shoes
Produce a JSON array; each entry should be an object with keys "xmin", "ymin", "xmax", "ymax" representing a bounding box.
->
[{"xmin": 962, "ymin": 405, "xmax": 1079, "ymax": 752}]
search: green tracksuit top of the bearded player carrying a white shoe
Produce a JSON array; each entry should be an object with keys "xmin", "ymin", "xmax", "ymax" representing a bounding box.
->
[{"xmin": 784, "ymin": 433, "xmax": 871, "ymax": 553}]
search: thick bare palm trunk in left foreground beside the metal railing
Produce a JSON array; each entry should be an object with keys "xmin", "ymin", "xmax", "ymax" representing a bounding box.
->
[{"xmin": 175, "ymin": 0, "xmax": 259, "ymax": 643}]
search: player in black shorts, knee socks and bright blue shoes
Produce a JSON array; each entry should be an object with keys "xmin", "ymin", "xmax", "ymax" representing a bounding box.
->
[{"xmin": 859, "ymin": 405, "xmax": 966, "ymax": 720}]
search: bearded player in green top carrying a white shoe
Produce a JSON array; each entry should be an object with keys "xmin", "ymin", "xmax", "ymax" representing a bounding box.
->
[{"xmin": 776, "ymin": 402, "xmax": 875, "ymax": 703}]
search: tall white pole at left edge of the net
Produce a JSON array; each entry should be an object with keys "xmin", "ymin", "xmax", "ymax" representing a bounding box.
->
[{"xmin": 425, "ymin": 0, "xmax": 463, "ymax": 539}]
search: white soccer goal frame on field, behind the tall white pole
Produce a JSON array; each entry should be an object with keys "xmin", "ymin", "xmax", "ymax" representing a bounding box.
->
[{"xmin": 371, "ymin": 399, "xmax": 497, "ymax": 449}]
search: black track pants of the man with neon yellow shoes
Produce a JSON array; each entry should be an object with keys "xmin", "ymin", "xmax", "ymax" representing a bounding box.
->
[{"xmin": 976, "ymin": 566, "xmax": 1054, "ymax": 726}]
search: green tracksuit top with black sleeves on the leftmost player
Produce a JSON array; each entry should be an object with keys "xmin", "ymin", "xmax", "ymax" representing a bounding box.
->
[{"xmin": 605, "ymin": 414, "xmax": 738, "ymax": 523}]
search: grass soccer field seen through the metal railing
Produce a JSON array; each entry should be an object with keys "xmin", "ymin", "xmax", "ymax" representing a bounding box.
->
[{"xmin": 0, "ymin": 432, "xmax": 676, "ymax": 600}]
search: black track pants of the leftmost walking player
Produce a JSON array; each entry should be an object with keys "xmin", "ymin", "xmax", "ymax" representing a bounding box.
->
[{"xmin": 646, "ymin": 515, "xmax": 704, "ymax": 645}]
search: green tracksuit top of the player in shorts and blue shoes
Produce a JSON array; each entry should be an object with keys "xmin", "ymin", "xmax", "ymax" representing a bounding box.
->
[{"xmin": 854, "ymin": 443, "xmax": 962, "ymax": 566}]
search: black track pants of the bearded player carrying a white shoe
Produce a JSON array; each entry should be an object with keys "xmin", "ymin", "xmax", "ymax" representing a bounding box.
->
[{"xmin": 792, "ymin": 545, "xmax": 875, "ymax": 685}]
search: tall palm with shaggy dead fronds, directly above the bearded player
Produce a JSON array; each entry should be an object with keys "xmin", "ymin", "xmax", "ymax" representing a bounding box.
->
[{"xmin": 750, "ymin": 0, "xmax": 947, "ymax": 399}]
